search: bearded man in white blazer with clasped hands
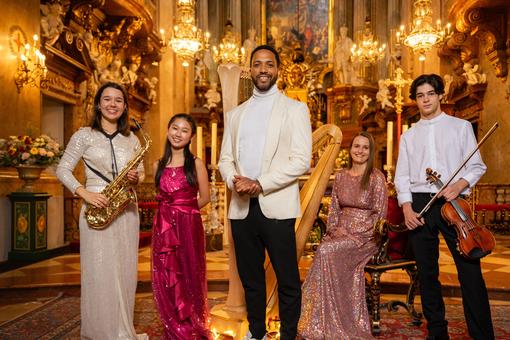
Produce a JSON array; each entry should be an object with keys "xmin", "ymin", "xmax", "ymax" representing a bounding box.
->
[{"xmin": 218, "ymin": 45, "xmax": 312, "ymax": 340}]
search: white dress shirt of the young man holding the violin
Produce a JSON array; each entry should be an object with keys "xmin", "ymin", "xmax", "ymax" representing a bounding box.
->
[{"xmin": 395, "ymin": 112, "xmax": 487, "ymax": 205}]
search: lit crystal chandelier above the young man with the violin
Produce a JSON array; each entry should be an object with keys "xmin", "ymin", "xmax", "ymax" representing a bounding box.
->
[{"xmin": 397, "ymin": 0, "xmax": 451, "ymax": 61}]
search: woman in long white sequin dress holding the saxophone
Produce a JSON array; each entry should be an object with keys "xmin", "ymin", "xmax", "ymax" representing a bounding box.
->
[{"xmin": 57, "ymin": 83, "xmax": 147, "ymax": 340}]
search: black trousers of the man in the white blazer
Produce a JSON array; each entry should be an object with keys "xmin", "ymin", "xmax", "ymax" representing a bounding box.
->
[{"xmin": 231, "ymin": 198, "xmax": 301, "ymax": 340}]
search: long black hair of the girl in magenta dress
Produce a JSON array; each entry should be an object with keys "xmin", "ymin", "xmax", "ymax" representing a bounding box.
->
[{"xmin": 154, "ymin": 113, "xmax": 198, "ymax": 188}]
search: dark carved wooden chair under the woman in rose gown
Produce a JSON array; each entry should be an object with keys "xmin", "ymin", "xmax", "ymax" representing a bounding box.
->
[{"xmin": 365, "ymin": 197, "xmax": 422, "ymax": 335}]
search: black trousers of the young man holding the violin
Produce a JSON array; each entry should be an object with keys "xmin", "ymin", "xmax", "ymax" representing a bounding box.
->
[{"xmin": 410, "ymin": 193, "xmax": 494, "ymax": 340}]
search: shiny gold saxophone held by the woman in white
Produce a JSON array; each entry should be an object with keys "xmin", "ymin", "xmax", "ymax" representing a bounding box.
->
[{"xmin": 85, "ymin": 119, "xmax": 152, "ymax": 230}]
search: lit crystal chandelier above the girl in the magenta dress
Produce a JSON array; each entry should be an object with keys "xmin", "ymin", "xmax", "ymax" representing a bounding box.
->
[{"xmin": 167, "ymin": 0, "xmax": 209, "ymax": 67}]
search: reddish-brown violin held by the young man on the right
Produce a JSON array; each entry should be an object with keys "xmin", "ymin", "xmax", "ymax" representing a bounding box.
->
[{"xmin": 426, "ymin": 168, "xmax": 496, "ymax": 259}]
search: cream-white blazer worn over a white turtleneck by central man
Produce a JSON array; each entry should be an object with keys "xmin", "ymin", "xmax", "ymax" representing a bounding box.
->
[{"xmin": 218, "ymin": 92, "xmax": 312, "ymax": 220}]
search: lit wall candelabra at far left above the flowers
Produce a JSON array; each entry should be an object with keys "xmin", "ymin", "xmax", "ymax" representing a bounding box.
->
[{"xmin": 14, "ymin": 34, "xmax": 48, "ymax": 93}]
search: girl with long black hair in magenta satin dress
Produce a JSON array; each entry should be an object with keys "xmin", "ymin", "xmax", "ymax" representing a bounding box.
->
[{"xmin": 152, "ymin": 114, "xmax": 210, "ymax": 340}]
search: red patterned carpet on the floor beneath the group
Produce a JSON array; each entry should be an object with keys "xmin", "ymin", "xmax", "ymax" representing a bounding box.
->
[{"xmin": 0, "ymin": 295, "xmax": 510, "ymax": 340}]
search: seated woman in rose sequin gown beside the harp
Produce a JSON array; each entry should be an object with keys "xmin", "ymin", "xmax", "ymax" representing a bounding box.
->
[{"xmin": 298, "ymin": 131, "xmax": 387, "ymax": 340}]
